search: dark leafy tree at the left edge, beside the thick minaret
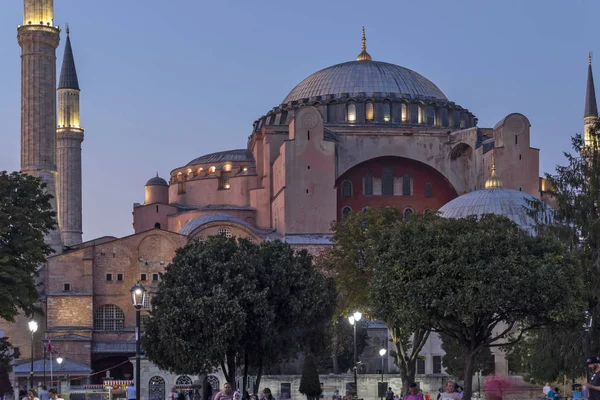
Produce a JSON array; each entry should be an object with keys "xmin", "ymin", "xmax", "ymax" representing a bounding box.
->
[{"xmin": 0, "ymin": 171, "xmax": 56, "ymax": 322}]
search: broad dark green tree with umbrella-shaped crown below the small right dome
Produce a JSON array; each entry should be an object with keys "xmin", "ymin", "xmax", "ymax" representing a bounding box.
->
[{"xmin": 371, "ymin": 215, "xmax": 583, "ymax": 400}]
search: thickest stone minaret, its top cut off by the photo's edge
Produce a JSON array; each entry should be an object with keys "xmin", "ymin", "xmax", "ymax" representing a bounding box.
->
[{"xmin": 17, "ymin": 0, "xmax": 62, "ymax": 252}]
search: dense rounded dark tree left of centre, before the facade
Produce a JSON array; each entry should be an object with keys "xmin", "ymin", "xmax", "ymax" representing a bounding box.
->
[{"xmin": 143, "ymin": 235, "xmax": 335, "ymax": 387}]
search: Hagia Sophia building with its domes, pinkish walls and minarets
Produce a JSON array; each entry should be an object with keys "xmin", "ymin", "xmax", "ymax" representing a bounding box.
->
[{"xmin": 0, "ymin": 0, "xmax": 598, "ymax": 399}]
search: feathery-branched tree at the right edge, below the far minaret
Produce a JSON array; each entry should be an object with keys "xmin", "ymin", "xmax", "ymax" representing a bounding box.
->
[{"xmin": 510, "ymin": 127, "xmax": 600, "ymax": 382}]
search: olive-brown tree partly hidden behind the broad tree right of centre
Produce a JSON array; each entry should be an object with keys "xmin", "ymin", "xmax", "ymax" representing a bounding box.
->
[{"xmin": 318, "ymin": 207, "xmax": 429, "ymax": 396}]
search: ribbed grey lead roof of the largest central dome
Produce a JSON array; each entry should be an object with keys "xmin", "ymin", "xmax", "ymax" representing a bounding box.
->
[{"xmin": 283, "ymin": 60, "xmax": 448, "ymax": 104}]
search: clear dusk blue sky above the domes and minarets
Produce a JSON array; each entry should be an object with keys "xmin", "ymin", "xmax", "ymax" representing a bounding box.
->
[{"xmin": 0, "ymin": 0, "xmax": 600, "ymax": 240}]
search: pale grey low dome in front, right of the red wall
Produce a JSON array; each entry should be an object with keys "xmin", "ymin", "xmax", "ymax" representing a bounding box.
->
[{"xmin": 439, "ymin": 187, "xmax": 549, "ymax": 233}]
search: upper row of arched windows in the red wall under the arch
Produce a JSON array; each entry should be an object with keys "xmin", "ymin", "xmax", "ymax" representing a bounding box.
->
[{"xmin": 342, "ymin": 177, "xmax": 433, "ymax": 198}]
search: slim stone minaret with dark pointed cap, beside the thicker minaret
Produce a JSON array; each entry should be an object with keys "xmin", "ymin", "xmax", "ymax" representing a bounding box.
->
[{"xmin": 56, "ymin": 26, "xmax": 83, "ymax": 246}]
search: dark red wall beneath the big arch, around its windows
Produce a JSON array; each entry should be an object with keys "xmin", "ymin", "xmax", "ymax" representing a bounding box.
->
[{"xmin": 336, "ymin": 157, "xmax": 457, "ymax": 219}]
